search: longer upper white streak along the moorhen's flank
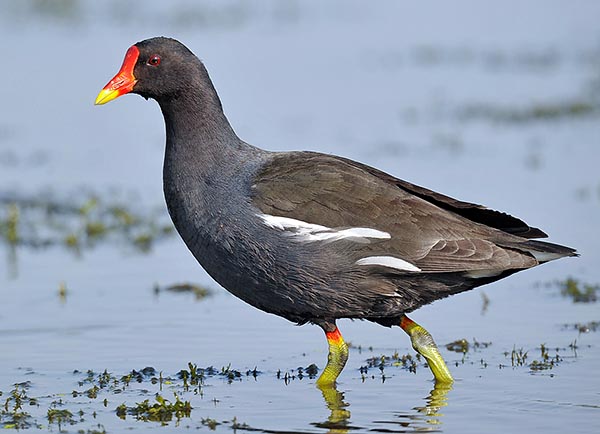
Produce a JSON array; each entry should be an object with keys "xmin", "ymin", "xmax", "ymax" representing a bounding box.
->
[{"xmin": 258, "ymin": 214, "xmax": 391, "ymax": 242}]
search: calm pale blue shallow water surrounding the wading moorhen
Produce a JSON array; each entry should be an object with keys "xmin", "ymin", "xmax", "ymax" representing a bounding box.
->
[{"xmin": 0, "ymin": 1, "xmax": 600, "ymax": 433}]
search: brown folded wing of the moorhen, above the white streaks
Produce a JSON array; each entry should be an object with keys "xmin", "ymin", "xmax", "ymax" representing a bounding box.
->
[{"xmin": 252, "ymin": 152, "xmax": 543, "ymax": 272}]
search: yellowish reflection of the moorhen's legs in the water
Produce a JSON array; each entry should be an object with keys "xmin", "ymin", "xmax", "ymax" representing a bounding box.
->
[{"xmin": 312, "ymin": 383, "xmax": 452, "ymax": 434}]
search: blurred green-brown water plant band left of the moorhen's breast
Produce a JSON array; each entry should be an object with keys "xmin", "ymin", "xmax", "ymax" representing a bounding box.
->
[{"xmin": 0, "ymin": 192, "xmax": 174, "ymax": 254}]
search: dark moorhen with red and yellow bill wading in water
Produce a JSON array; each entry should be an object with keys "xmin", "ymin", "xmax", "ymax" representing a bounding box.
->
[{"xmin": 96, "ymin": 37, "xmax": 577, "ymax": 386}]
